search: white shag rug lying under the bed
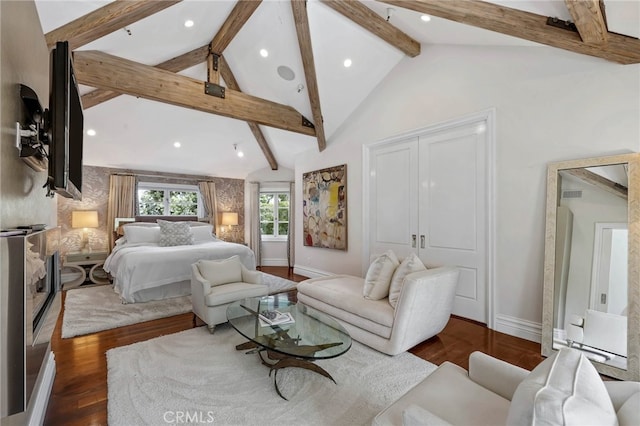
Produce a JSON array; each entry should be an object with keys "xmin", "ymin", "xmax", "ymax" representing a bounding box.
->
[{"xmin": 62, "ymin": 272, "xmax": 296, "ymax": 338}]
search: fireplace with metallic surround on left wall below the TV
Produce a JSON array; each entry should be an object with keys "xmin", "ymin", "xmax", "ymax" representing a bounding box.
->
[{"xmin": 0, "ymin": 228, "xmax": 61, "ymax": 425}]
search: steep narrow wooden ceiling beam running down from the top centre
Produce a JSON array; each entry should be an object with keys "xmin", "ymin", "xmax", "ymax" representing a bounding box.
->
[{"xmin": 291, "ymin": 0, "xmax": 327, "ymax": 151}]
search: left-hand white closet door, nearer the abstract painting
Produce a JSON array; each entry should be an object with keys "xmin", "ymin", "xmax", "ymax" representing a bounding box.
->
[{"xmin": 369, "ymin": 138, "xmax": 418, "ymax": 258}]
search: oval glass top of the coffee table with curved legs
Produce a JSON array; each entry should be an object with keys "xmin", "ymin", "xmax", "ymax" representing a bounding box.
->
[{"xmin": 227, "ymin": 296, "xmax": 351, "ymax": 360}]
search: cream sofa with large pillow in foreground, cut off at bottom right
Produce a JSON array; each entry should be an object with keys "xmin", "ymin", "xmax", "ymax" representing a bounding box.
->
[{"xmin": 373, "ymin": 348, "xmax": 640, "ymax": 426}]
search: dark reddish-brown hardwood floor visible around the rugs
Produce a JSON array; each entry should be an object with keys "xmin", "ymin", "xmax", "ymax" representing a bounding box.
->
[{"xmin": 45, "ymin": 267, "xmax": 542, "ymax": 426}]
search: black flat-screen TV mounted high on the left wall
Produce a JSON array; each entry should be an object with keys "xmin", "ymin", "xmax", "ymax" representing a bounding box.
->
[{"xmin": 49, "ymin": 41, "xmax": 84, "ymax": 200}]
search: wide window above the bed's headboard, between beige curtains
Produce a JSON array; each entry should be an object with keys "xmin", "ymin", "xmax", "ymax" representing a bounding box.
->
[{"xmin": 138, "ymin": 182, "xmax": 202, "ymax": 217}]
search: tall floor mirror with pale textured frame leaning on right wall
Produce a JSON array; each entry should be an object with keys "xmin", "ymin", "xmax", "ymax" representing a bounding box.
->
[{"xmin": 542, "ymin": 153, "xmax": 640, "ymax": 381}]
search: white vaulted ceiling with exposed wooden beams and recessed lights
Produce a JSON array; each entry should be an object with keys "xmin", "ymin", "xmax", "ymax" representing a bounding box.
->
[{"xmin": 36, "ymin": 0, "xmax": 640, "ymax": 178}]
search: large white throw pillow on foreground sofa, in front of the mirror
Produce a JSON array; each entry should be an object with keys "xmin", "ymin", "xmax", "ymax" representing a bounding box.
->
[{"xmin": 507, "ymin": 348, "xmax": 618, "ymax": 425}]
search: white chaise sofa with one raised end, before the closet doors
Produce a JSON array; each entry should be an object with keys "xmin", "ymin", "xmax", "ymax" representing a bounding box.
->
[{"xmin": 298, "ymin": 266, "xmax": 459, "ymax": 355}]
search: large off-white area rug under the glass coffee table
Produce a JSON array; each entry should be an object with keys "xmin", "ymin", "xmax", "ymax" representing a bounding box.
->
[{"xmin": 107, "ymin": 324, "xmax": 436, "ymax": 426}]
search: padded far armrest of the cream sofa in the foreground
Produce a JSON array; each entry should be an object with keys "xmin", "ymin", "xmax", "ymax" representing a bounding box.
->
[{"xmin": 469, "ymin": 351, "xmax": 529, "ymax": 401}]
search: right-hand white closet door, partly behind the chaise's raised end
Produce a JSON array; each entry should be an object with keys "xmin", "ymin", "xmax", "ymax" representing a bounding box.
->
[{"xmin": 419, "ymin": 122, "xmax": 487, "ymax": 323}]
